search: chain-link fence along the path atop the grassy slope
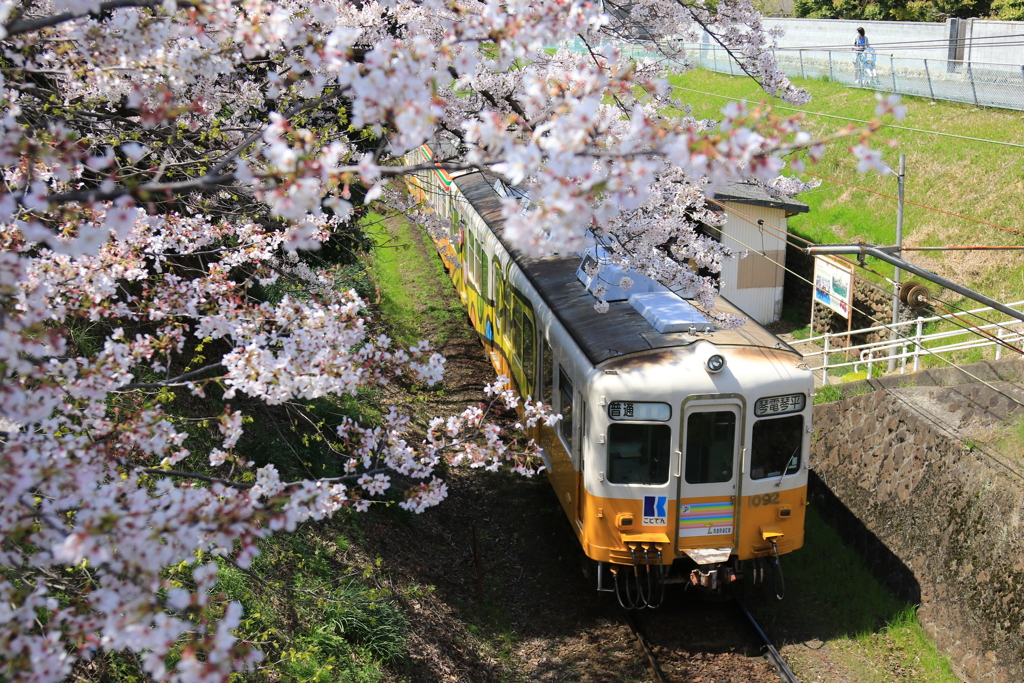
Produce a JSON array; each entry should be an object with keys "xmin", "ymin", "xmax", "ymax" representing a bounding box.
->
[{"xmin": 685, "ymin": 44, "xmax": 1024, "ymax": 110}]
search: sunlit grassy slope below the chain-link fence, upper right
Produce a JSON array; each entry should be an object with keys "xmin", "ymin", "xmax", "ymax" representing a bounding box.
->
[{"xmin": 674, "ymin": 71, "xmax": 1024, "ymax": 307}]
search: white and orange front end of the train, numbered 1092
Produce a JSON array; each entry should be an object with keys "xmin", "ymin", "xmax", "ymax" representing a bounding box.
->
[{"xmin": 581, "ymin": 301, "xmax": 813, "ymax": 608}]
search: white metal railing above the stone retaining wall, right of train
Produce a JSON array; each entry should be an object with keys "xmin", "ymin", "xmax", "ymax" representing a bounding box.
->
[{"xmin": 790, "ymin": 301, "xmax": 1024, "ymax": 385}]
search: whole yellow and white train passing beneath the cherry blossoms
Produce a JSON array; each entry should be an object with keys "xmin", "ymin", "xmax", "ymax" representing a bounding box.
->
[{"xmin": 408, "ymin": 146, "xmax": 813, "ymax": 608}]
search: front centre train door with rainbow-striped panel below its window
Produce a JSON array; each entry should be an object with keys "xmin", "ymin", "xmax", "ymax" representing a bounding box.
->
[{"xmin": 676, "ymin": 397, "xmax": 743, "ymax": 557}]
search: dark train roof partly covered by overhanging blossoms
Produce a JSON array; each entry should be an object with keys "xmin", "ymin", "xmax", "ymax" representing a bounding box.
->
[{"xmin": 455, "ymin": 172, "xmax": 792, "ymax": 366}]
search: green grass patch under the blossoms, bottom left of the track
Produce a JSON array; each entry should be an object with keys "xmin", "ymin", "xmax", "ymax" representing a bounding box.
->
[{"xmin": 217, "ymin": 514, "xmax": 410, "ymax": 683}]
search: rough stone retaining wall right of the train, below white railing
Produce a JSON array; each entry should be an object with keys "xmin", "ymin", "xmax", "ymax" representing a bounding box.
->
[{"xmin": 811, "ymin": 360, "xmax": 1024, "ymax": 683}]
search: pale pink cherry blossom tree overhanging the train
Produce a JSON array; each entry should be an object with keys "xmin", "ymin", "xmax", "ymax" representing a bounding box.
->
[{"xmin": 0, "ymin": 0, "xmax": 895, "ymax": 681}]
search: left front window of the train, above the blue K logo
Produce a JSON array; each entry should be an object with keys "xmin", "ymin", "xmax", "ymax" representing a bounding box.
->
[{"xmin": 608, "ymin": 422, "xmax": 672, "ymax": 484}]
